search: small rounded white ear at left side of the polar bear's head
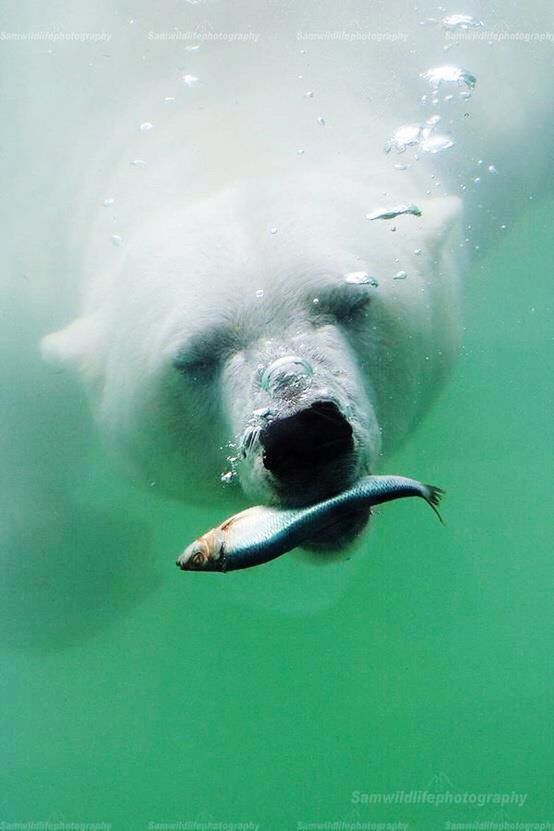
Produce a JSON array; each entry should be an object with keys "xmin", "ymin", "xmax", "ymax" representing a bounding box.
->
[{"xmin": 40, "ymin": 315, "xmax": 103, "ymax": 376}]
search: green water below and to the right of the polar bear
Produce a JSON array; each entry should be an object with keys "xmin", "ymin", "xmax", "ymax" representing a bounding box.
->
[{"xmin": 0, "ymin": 206, "xmax": 554, "ymax": 829}]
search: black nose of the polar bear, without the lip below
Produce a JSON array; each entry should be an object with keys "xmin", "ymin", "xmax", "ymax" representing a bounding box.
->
[{"xmin": 260, "ymin": 401, "xmax": 354, "ymax": 485}]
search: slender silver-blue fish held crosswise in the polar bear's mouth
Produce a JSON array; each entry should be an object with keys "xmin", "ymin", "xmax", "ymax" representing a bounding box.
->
[{"xmin": 177, "ymin": 476, "xmax": 443, "ymax": 571}]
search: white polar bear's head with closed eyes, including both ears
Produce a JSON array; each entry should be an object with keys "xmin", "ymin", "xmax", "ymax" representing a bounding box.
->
[{"xmin": 43, "ymin": 171, "xmax": 459, "ymax": 544}]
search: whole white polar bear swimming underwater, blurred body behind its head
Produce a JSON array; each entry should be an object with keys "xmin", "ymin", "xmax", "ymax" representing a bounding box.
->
[{"xmin": 2, "ymin": 0, "xmax": 553, "ymax": 636}]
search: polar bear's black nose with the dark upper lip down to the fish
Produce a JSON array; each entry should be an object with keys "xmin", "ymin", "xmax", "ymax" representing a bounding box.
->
[{"xmin": 260, "ymin": 401, "xmax": 356, "ymax": 503}]
